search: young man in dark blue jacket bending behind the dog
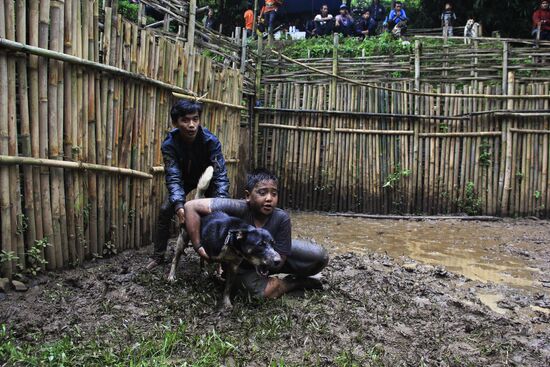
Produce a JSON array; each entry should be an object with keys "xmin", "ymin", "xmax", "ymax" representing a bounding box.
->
[{"xmin": 147, "ymin": 100, "xmax": 229, "ymax": 270}]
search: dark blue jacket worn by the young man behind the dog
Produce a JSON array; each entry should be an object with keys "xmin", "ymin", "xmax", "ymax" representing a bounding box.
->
[{"xmin": 161, "ymin": 126, "xmax": 229, "ymax": 211}]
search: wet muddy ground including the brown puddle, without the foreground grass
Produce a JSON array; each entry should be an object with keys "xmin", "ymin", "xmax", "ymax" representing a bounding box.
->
[{"xmin": 0, "ymin": 213, "xmax": 550, "ymax": 366}]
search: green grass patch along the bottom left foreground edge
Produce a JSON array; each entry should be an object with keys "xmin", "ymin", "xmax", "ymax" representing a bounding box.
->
[{"xmin": 0, "ymin": 323, "xmax": 236, "ymax": 367}]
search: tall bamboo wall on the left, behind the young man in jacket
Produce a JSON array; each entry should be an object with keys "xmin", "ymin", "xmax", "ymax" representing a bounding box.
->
[{"xmin": 0, "ymin": 0, "xmax": 250, "ymax": 277}]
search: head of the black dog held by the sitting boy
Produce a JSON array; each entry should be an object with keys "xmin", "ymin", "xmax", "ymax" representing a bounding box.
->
[{"xmin": 226, "ymin": 226, "xmax": 282, "ymax": 276}]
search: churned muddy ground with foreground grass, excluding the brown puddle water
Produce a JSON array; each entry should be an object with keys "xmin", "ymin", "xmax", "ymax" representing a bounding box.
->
[{"xmin": 0, "ymin": 217, "xmax": 550, "ymax": 366}]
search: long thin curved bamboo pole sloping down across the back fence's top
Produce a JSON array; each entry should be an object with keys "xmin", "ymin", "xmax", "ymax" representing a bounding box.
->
[{"xmin": 271, "ymin": 50, "xmax": 550, "ymax": 99}]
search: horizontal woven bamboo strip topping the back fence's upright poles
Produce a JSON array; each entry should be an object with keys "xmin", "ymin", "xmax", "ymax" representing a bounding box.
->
[{"xmin": 263, "ymin": 37, "xmax": 550, "ymax": 84}]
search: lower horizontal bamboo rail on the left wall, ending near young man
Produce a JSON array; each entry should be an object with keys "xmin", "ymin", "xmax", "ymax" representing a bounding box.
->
[{"xmin": 0, "ymin": 155, "xmax": 153, "ymax": 180}]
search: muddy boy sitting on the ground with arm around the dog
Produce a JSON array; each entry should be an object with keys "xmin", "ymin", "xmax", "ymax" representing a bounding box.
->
[{"xmin": 185, "ymin": 169, "xmax": 328, "ymax": 298}]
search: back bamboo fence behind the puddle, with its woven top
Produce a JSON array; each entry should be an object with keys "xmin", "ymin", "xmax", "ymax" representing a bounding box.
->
[{"xmin": 256, "ymin": 37, "xmax": 550, "ymax": 217}]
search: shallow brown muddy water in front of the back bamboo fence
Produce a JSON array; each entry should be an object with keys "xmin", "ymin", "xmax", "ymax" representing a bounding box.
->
[{"xmin": 291, "ymin": 212, "xmax": 550, "ymax": 313}]
